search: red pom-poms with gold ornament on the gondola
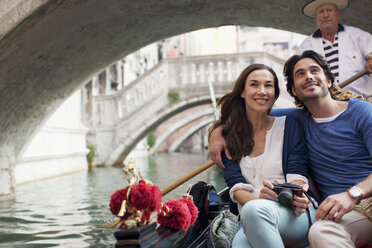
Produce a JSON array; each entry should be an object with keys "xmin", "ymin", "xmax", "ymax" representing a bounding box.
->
[{"xmin": 109, "ymin": 159, "xmax": 198, "ymax": 230}]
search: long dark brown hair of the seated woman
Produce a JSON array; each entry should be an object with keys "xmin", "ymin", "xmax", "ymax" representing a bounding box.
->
[{"xmin": 209, "ymin": 64, "xmax": 279, "ymax": 161}]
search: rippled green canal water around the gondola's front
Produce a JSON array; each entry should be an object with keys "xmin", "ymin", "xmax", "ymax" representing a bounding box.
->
[{"xmin": 0, "ymin": 153, "xmax": 225, "ymax": 248}]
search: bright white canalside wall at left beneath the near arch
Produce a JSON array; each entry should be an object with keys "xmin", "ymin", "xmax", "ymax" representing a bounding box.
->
[{"xmin": 14, "ymin": 90, "xmax": 88, "ymax": 184}]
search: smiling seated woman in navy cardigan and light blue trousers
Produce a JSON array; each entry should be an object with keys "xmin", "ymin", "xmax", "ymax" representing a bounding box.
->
[{"xmin": 210, "ymin": 64, "xmax": 315, "ymax": 247}]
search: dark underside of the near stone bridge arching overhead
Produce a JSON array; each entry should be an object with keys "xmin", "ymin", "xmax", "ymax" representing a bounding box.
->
[{"xmin": 0, "ymin": 0, "xmax": 372, "ymax": 195}]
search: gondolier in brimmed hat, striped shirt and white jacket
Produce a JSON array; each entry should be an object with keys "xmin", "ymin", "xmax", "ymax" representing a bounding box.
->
[{"xmin": 298, "ymin": 0, "xmax": 372, "ymax": 101}]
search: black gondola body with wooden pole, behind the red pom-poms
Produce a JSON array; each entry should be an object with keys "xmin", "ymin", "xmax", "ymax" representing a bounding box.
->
[{"xmin": 109, "ymin": 161, "xmax": 230, "ymax": 248}]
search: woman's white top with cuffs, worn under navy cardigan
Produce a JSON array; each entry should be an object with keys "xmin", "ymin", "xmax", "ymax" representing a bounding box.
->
[{"xmin": 230, "ymin": 116, "xmax": 308, "ymax": 212}]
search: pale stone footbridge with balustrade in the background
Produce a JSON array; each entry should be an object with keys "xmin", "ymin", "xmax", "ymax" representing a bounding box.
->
[{"xmin": 88, "ymin": 53, "xmax": 291, "ymax": 165}]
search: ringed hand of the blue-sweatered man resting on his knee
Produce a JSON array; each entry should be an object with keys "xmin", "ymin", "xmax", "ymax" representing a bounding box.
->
[{"xmin": 315, "ymin": 192, "xmax": 358, "ymax": 222}]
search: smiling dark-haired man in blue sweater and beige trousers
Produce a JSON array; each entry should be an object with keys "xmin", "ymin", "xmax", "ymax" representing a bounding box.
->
[{"xmin": 284, "ymin": 51, "xmax": 372, "ymax": 247}]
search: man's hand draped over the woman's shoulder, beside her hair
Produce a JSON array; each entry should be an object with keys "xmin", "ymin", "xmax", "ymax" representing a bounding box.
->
[{"xmin": 209, "ymin": 126, "xmax": 231, "ymax": 169}]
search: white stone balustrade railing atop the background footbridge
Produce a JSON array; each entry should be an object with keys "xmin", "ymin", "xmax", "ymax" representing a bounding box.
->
[{"xmin": 87, "ymin": 53, "xmax": 283, "ymax": 126}]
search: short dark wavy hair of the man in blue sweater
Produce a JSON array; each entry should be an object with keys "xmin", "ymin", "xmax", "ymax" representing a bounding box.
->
[{"xmin": 283, "ymin": 50, "xmax": 336, "ymax": 108}]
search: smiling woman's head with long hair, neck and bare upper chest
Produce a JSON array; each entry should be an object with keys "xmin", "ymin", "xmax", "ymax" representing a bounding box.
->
[{"xmin": 211, "ymin": 64, "xmax": 279, "ymax": 161}]
